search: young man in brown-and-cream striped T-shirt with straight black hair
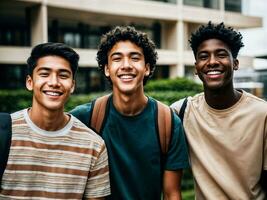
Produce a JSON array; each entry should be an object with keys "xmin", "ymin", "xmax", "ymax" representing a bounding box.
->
[{"xmin": 0, "ymin": 43, "xmax": 110, "ymax": 200}]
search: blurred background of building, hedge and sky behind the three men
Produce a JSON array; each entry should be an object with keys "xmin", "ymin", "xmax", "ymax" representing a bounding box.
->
[{"xmin": 0, "ymin": 0, "xmax": 267, "ymax": 200}]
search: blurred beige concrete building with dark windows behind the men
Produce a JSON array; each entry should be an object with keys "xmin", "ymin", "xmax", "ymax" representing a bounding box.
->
[{"xmin": 0, "ymin": 0, "xmax": 262, "ymax": 93}]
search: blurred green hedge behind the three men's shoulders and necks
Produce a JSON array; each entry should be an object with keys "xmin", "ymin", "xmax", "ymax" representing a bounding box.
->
[{"xmin": 0, "ymin": 78, "xmax": 202, "ymax": 113}]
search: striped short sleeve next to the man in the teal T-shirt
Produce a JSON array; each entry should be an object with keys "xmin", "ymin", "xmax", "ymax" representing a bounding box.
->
[{"xmin": 84, "ymin": 143, "xmax": 110, "ymax": 198}]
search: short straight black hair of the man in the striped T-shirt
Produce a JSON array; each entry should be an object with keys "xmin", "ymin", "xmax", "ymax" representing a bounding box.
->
[{"xmin": 27, "ymin": 42, "xmax": 80, "ymax": 78}]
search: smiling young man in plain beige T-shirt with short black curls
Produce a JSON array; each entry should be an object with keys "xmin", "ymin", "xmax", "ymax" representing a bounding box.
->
[{"xmin": 171, "ymin": 22, "xmax": 267, "ymax": 200}]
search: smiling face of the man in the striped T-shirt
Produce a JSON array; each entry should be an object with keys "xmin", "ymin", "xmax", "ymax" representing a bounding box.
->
[{"xmin": 26, "ymin": 56, "xmax": 75, "ymax": 112}]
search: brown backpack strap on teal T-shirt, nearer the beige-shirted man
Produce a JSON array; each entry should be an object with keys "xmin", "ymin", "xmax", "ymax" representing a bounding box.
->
[{"xmin": 157, "ymin": 101, "xmax": 172, "ymax": 156}]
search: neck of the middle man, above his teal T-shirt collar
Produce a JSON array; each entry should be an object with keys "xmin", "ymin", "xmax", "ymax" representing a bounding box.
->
[{"xmin": 113, "ymin": 93, "xmax": 148, "ymax": 116}]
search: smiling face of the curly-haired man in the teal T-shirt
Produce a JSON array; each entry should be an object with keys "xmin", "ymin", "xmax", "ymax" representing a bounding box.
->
[{"xmin": 105, "ymin": 40, "xmax": 150, "ymax": 94}]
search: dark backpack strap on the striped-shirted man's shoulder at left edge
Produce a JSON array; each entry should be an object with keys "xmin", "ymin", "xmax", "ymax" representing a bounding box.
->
[{"xmin": 0, "ymin": 113, "xmax": 12, "ymax": 182}]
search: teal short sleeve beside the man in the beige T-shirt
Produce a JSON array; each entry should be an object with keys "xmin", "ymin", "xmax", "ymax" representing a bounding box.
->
[{"xmin": 165, "ymin": 112, "xmax": 189, "ymax": 170}]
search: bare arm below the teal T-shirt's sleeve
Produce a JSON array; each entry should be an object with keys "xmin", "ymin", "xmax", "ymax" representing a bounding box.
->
[{"xmin": 163, "ymin": 170, "xmax": 182, "ymax": 200}]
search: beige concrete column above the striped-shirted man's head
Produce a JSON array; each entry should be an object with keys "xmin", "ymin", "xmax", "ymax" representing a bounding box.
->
[{"xmin": 31, "ymin": 3, "xmax": 48, "ymax": 46}]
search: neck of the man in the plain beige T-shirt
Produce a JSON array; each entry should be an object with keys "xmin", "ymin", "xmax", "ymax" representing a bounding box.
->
[{"xmin": 204, "ymin": 86, "xmax": 242, "ymax": 110}]
